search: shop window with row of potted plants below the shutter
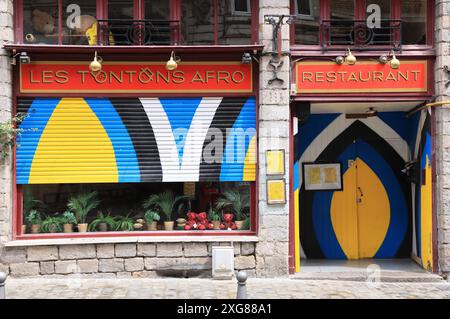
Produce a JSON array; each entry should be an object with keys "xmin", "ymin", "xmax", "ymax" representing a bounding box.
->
[{"xmin": 22, "ymin": 182, "xmax": 251, "ymax": 234}]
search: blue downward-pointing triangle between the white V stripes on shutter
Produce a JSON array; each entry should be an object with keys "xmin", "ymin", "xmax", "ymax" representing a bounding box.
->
[{"xmin": 159, "ymin": 98, "xmax": 202, "ymax": 165}]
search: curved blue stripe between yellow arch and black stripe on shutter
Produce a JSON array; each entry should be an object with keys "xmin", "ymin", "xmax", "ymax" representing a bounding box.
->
[{"xmin": 85, "ymin": 98, "xmax": 141, "ymax": 183}]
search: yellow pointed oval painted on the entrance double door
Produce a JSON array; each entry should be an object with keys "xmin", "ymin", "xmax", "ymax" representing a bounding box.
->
[{"xmin": 331, "ymin": 157, "xmax": 390, "ymax": 259}]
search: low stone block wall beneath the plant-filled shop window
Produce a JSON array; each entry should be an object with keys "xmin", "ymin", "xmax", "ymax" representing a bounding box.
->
[{"xmin": 0, "ymin": 243, "xmax": 256, "ymax": 277}]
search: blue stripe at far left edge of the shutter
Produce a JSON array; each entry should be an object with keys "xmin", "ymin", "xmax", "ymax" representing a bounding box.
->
[{"xmin": 16, "ymin": 98, "xmax": 61, "ymax": 184}]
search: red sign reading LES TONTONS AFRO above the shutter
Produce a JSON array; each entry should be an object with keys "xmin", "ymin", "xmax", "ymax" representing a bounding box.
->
[{"xmin": 20, "ymin": 61, "xmax": 253, "ymax": 93}]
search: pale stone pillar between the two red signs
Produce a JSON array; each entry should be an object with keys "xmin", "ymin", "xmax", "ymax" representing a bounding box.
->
[{"xmin": 256, "ymin": 0, "xmax": 290, "ymax": 277}]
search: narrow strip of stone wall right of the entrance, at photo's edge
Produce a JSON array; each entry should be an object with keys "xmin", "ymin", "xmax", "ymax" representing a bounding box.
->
[{"xmin": 435, "ymin": 0, "xmax": 450, "ymax": 273}]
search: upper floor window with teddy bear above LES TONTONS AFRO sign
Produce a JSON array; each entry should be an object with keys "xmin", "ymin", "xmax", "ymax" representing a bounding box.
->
[{"xmin": 17, "ymin": 0, "xmax": 258, "ymax": 45}]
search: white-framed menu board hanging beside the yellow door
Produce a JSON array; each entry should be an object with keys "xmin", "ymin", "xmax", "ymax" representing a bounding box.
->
[{"xmin": 303, "ymin": 162, "xmax": 342, "ymax": 191}]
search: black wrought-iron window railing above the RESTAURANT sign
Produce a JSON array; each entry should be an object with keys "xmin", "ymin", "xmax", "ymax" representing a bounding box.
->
[{"xmin": 320, "ymin": 19, "xmax": 402, "ymax": 50}]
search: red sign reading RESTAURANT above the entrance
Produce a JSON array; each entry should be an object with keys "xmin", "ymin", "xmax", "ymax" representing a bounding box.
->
[{"xmin": 296, "ymin": 60, "xmax": 428, "ymax": 94}]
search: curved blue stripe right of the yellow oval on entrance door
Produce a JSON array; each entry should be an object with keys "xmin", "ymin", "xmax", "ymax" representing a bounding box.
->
[{"xmin": 357, "ymin": 140, "xmax": 408, "ymax": 258}]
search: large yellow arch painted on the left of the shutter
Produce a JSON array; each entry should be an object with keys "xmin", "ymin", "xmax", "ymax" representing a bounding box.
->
[{"xmin": 29, "ymin": 98, "xmax": 118, "ymax": 184}]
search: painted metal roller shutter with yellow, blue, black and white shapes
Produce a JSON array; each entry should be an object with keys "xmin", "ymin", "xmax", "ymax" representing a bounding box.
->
[{"xmin": 16, "ymin": 97, "xmax": 256, "ymax": 184}]
